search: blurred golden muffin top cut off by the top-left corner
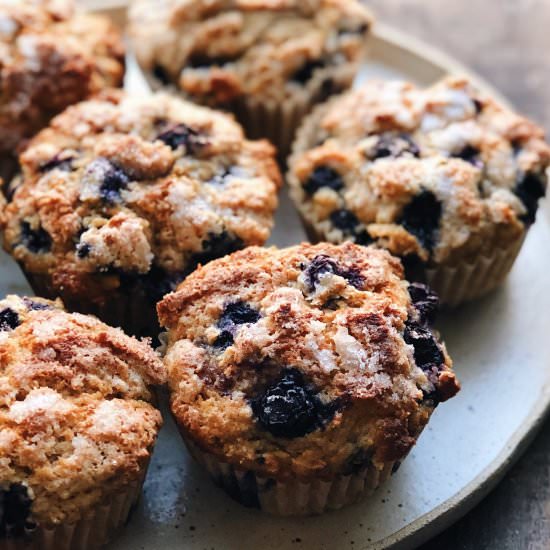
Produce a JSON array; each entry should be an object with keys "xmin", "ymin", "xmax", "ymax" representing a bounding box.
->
[{"xmin": 0, "ymin": 0, "xmax": 124, "ymax": 153}]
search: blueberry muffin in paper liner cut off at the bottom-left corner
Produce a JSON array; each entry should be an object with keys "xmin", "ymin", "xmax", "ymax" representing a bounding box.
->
[{"xmin": 0, "ymin": 296, "xmax": 165, "ymax": 550}]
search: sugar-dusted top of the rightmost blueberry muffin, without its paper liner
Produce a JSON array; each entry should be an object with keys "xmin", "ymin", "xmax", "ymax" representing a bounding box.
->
[{"xmin": 290, "ymin": 77, "xmax": 550, "ymax": 264}]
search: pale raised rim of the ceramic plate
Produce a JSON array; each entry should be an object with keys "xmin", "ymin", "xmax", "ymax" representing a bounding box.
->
[{"xmin": 75, "ymin": 0, "xmax": 550, "ymax": 550}]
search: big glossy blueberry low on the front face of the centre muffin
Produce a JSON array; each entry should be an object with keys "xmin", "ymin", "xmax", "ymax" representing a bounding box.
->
[{"xmin": 252, "ymin": 369, "xmax": 335, "ymax": 438}]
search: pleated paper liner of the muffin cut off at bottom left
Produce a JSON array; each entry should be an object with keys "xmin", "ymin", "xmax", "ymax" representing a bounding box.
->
[{"xmin": 0, "ymin": 468, "xmax": 147, "ymax": 550}]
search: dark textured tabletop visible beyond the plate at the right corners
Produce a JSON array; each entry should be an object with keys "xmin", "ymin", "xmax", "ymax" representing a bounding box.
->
[{"xmin": 367, "ymin": 0, "xmax": 550, "ymax": 550}]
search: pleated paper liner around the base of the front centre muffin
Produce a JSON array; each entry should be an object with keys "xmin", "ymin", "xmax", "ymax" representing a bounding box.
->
[{"xmin": 182, "ymin": 434, "xmax": 398, "ymax": 516}]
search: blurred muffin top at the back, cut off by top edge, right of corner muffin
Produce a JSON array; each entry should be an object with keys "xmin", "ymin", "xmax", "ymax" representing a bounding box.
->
[{"xmin": 130, "ymin": 0, "xmax": 372, "ymax": 104}]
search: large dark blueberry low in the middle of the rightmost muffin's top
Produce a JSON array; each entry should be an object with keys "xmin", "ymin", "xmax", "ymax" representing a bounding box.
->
[{"xmin": 399, "ymin": 190, "xmax": 441, "ymax": 251}]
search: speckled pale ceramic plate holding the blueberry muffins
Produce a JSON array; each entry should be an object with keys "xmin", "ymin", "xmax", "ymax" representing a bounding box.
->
[{"xmin": 5, "ymin": 6, "xmax": 550, "ymax": 550}]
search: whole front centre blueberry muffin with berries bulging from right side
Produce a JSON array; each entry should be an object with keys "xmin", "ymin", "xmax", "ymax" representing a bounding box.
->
[{"xmin": 158, "ymin": 243, "xmax": 459, "ymax": 515}]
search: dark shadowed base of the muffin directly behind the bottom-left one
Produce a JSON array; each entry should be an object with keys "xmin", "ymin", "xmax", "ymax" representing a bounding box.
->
[{"xmin": 21, "ymin": 272, "xmax": 161, "ymax": 339}]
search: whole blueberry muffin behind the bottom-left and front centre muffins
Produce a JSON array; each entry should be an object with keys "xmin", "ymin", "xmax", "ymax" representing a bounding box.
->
[{"xmin": 1, "ymin": 92, "xmax": 281, "ymax": 336}]
